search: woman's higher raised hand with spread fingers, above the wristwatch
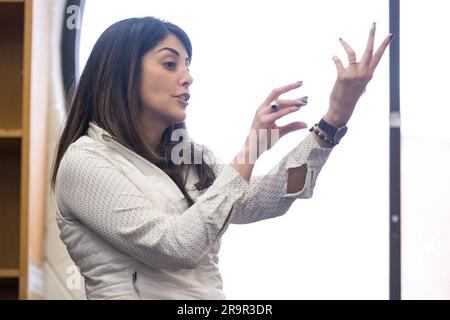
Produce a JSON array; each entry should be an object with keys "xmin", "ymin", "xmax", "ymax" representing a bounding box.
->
[{"xmin": 324, "ymin": 23, "xmax": 393, "ymax": 127}]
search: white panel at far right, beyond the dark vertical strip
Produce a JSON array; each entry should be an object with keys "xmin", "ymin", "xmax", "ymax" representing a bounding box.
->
[{"xmin": 400, "ymin": 0, "xmax": 450, "ymax": 299}]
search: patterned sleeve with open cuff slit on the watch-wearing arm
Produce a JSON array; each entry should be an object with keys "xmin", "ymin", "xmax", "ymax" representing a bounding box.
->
[{"xmin": 206, "ymin": 134, "xmax": 332, "ymax": 224}]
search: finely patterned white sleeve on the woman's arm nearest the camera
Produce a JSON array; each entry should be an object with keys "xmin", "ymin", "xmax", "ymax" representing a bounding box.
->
[{"xmin": 56, "ymin": 147, "xmax": 248, "ymax": 270}]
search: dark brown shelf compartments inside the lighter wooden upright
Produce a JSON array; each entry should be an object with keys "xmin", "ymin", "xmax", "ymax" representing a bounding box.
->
[{"xmin": 0, "ymin": 1, "xmax": 26, "ymax": 299}]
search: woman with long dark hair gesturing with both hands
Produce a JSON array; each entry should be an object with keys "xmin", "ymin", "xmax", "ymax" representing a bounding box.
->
[{"xmin": 52, "ymin": 17, "xmax": 392, "ymax": 299}]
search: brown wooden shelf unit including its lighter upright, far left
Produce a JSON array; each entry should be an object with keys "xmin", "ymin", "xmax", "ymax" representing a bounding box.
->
[{"xmin": 0, "ymin": 0, "xmax": 31, "ymax": 299}]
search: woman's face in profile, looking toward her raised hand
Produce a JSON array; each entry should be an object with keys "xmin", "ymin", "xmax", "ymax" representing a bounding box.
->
[{"xmin": 140, "ymin": 34, "xmax": 193, "ymax": 128}]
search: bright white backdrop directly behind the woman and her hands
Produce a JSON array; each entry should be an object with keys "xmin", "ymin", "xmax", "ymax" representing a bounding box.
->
[{"xmin": 81, "ymin": 0, "xmax": 389, "ymax": 299}]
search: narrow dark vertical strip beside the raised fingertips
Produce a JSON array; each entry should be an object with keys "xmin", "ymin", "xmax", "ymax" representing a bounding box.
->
[{"xmin": 389, "ymin": 0, "xmax": 401, "ymax": 300}]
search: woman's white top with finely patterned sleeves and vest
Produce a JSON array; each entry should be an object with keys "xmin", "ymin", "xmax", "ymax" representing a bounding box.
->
[{"xmin": 55, "ymin": 123, "xmax": 331, "ymax": 299}]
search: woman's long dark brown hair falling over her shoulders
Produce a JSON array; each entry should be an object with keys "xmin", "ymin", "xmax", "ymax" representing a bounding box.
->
[{"xmin": 51, "ymin": 17, "xmax": 215, "ymax": 206}]
